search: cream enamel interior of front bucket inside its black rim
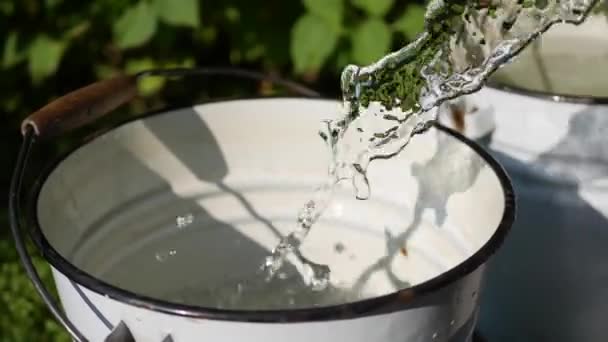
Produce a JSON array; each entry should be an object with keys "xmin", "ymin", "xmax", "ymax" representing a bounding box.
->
[{"xmin": 38, "ymin": 99, "xmax": 505, "ymax": 310}]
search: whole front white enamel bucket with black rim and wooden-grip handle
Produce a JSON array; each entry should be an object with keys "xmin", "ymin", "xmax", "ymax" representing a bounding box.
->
[{"xmin": 10, "ymin": 70, "xmax": 514, "ymax": 342}]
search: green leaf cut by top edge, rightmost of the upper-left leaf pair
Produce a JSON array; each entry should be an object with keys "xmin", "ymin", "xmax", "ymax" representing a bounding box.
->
[{"xmin": 155, "ymin": 0, "xmax": 200, "ymax": 27}]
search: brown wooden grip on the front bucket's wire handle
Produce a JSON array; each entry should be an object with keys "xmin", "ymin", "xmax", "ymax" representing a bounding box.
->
[{"xmin": 21, "ymin": 76, "xmax": 137, "ymax": 139}]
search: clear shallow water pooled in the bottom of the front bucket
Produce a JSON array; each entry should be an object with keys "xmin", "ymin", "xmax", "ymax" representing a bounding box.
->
[{"xmin": 74, "ymin": 184, "xmax": 460, "ymax": 309}]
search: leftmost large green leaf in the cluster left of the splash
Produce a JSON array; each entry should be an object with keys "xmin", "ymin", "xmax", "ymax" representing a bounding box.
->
[{"xmin": 290, "ymin": 14, "xmax": 338, "ymax": 73}]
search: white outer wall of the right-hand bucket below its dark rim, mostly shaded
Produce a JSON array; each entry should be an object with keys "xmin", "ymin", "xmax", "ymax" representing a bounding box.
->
[{"xmin": 470, "ymin": 85, "xmax": 608, "ymax": 342}]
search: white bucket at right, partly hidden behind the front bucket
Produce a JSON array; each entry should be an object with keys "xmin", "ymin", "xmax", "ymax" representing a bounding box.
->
[{"xmin": 442, "ymin": 17, "xmax": 608, "ymax": 342}]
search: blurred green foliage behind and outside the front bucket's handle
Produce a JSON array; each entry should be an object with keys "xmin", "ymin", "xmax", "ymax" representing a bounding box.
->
[{"xmin": 0, "ymin": 0, "xmax": 424, "ymax": 342}]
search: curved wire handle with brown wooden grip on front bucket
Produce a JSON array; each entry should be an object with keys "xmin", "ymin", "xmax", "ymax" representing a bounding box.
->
[{"xmin": 8, "ymin": 68, "xmax": 320, "ymax": 342}]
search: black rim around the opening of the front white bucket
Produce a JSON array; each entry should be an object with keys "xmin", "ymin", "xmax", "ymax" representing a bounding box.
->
[{"xmin": 26, "ymin": 96, "xmax": 516, "ymax": 323}]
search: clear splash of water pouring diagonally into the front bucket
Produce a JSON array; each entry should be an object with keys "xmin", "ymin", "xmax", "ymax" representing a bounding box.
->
[{"xmin": 263, "ymin": 0, "xmax": 598, "ymax": 290}]
